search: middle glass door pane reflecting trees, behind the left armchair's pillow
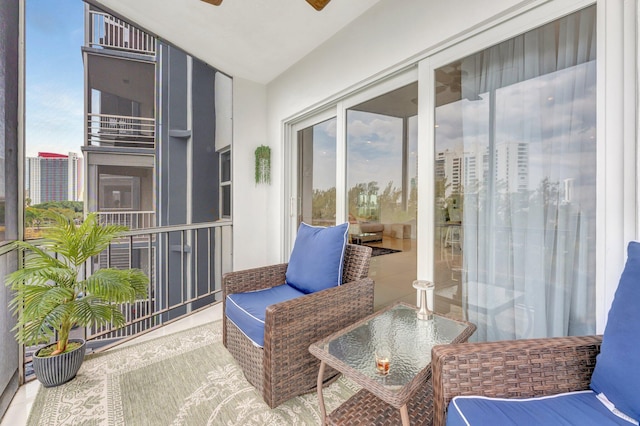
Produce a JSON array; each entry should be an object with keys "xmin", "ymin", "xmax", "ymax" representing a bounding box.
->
[{"xmin": 346, "ymin": 83, "xmax": 418, "ymax": 307}]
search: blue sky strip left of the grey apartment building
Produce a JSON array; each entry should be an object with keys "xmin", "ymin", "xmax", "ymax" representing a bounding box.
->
[{"xmin": 25, "ymin": 0, "xmax": 84, "ymax": 157}]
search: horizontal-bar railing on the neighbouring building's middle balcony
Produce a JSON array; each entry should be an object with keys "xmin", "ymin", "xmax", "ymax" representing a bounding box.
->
[{"xmin": 87, "ymin": 114, "xmax": 156, "ymax": 149}]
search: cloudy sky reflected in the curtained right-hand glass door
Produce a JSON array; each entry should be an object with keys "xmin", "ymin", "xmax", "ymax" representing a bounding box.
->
[{"xmin": 435, "ymin": 61, "xmax": 596, "ymax": 208}]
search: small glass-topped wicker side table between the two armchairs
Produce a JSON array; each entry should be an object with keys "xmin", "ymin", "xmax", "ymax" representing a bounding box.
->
[{"xmin": 309, "ymin": 303, "xmax": 476, "ymax": 425}]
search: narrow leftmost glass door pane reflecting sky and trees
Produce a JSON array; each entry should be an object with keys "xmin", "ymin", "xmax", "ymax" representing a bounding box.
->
[{"xmin": 298, "ymin": 118, "xmax": 342, "ymax": 226}]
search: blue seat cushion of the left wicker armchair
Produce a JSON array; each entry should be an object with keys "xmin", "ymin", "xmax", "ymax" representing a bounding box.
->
[{"xmin": 225, "ymin": 284, "xmax": 305, "ymax": 348}]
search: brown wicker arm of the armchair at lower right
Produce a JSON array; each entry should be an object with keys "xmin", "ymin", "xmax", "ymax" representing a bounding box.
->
[{"xmin": 431, "ymin": 336, "xmax": 602, "ymax": 426}]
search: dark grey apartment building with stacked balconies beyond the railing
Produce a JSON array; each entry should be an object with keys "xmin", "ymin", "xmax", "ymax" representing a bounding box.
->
[{"xmin": 82, "ymin": 4, "xmax": 231, "ymax": 319}]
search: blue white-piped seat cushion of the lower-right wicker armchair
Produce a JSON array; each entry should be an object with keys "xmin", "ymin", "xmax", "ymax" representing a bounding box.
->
[{"xmin": 447, "ymin": 390, "xmax": 632, "ymax": 426}]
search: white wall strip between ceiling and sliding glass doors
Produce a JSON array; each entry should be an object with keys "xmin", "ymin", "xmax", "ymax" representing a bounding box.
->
[{"xmin": 268, "ymin": 0, "xmax": 532, "ymax": 118}]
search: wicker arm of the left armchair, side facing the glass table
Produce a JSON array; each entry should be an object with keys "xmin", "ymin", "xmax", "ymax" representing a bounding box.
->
[{"xmin": 264, "ymin": 278, "xmax": 374, "ymax": 388}]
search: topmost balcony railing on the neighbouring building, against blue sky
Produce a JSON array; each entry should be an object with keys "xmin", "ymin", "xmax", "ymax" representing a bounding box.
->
[{"xmin": 88, "ymin": 10, "xmax": 156, "ymax": 56}]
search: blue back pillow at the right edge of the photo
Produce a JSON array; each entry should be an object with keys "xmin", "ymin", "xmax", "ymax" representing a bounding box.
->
[{"xmin": 591, "ymin": 241, "xmax": 640, "ymax": 420}]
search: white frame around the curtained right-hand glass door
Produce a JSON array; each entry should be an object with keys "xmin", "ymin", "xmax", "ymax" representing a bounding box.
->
[{"xmin": 418, "ymin": 0, "xmax": 639, "ymax": 333}]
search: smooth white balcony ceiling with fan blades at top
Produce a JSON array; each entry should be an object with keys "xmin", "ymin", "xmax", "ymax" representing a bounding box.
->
[{"xmin": 93, "ymin": 0, "xmax": 380, "ymax": 84}]
